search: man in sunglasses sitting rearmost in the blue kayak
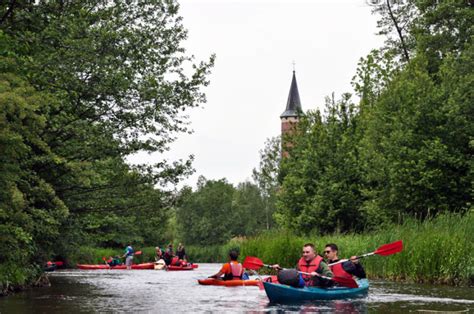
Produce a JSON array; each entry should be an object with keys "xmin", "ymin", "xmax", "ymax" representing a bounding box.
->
[{"xmin": 324, "ymin": 243, "xmax": 366, "ymax": 279}]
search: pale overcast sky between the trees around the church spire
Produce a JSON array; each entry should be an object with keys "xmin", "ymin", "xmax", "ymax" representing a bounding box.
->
[{"xmin": 132, "ymin": 0, "xmax": 383, "ymax": 187}]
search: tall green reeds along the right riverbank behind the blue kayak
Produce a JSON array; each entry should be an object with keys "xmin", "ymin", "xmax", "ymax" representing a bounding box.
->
[{"xmin": 241, "ymin": 212, "xmax": 474, "ymax": 285}]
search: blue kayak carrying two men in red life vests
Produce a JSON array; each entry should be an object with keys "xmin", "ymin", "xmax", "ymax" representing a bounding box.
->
[{"xmin": 263, "ymin": 279, "xmax": 369, "ymax": 303}]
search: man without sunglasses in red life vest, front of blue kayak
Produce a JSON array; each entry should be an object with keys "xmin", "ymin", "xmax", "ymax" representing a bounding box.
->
[{"xmin": 272, "ymin": 243, "xmax": 333, "ymax": 287}]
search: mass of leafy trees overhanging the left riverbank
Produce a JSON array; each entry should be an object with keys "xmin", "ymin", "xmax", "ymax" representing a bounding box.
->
[{"xmin": 0, "ymin": 0, "xmax": 214, "ymax": 290}]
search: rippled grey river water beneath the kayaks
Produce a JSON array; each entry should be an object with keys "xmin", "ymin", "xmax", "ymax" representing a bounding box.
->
[{"xmin": 0, "ymin": 264, "xmax": 474, "ymax": 313}]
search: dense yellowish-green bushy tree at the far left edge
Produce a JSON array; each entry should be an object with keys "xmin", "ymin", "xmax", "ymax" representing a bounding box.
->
[{"xmin": 0, "ymin": 49, "xmax": 68, "ymax": 288}]
